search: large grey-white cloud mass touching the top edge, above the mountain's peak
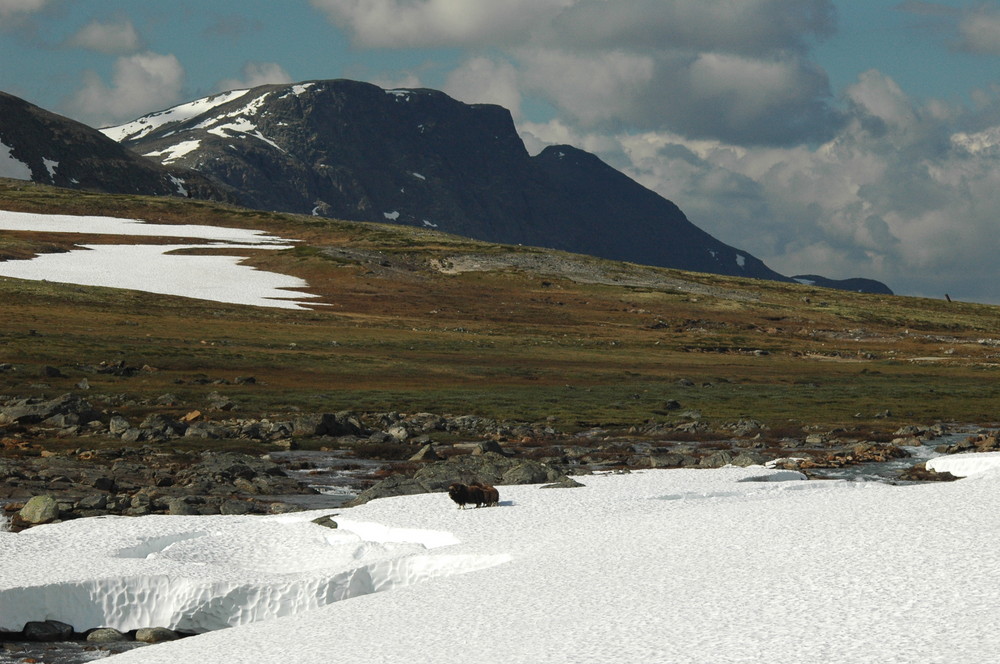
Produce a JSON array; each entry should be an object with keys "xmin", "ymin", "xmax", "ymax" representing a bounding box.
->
[{"xmin": 312, "ymin": 0, "xmax": 841, "ymax": 145}]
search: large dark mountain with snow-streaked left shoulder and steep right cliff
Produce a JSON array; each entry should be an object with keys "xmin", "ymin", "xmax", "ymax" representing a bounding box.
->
[{"xmin": 102, "ymin": 80, "xmax": 800, "ymax": 281}]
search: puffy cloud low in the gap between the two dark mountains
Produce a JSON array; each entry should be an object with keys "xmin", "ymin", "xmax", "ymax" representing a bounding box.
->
[{"xmin": 67, "ymin": 51, "xmax": 184, "ymax": 126}]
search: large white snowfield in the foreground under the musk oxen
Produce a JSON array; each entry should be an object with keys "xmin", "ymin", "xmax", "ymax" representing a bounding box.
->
[{"xmin": 0, "ymin": 454, "xmax": 1000, "ymax": 664}]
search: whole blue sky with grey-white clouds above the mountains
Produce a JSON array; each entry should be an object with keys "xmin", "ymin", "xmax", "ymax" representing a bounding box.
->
[{"xmin": 0, "ymin": 0, "xmax": 1000, "ymax": 304}]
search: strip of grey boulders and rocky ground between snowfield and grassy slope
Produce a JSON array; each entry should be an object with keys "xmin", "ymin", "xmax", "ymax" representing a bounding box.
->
[{"xmin": 0, "ymin": 394, "xmax": 976, "ymax": 530}]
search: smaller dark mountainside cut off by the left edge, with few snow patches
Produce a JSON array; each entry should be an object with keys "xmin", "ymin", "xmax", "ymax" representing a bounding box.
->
[{"xmin": 0, "ymin": 92, "xmax": 233, "ymax": 200}]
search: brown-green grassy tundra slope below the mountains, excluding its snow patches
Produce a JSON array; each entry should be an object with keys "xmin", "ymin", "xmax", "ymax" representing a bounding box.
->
[{"xmin": 0, "ymin": 180, "xmax": 1000, "ymax": 429}]
